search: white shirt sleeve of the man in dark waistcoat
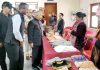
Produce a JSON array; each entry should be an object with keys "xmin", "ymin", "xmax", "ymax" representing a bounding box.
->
[{"xmin": 12, "ymin": 14, "xmax": 23, "ymax": 41}]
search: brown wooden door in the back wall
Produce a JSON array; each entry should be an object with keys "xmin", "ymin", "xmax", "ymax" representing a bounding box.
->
[{"xmin": 45, "ymin": 3, "xmax": 57, "ymax": 25}]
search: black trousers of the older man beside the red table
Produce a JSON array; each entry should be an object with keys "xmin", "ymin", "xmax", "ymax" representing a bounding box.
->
[{"xmin": 32, "ymin": 45, "xmax": 43, "ymax": 67}]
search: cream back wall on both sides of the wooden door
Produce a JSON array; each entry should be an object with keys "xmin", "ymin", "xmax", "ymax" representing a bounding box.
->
[{"xmin": 0, "ymin": 0, "xmax": 80, "ymax": 26}]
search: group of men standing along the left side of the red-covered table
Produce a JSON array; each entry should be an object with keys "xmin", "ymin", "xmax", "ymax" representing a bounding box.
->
[{"xmin": 0, "ymin": 1, "xmax": 43, "ymax": 70}]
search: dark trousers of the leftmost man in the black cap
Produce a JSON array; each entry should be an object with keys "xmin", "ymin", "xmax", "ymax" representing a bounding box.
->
[{"xmin": 0, "ymin": 46, "xmax": 7, "ymax": 70}]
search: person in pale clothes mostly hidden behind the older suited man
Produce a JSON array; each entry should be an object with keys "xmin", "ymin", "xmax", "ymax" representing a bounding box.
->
[{"xmin": 24, "ymin": 9, "xmax": 33, "ymax": 60}]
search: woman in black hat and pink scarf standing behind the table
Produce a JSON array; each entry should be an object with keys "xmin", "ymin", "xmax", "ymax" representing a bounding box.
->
[{"xmin": 71, "ymin": 12, "xmax": 86, "ymax": 51}]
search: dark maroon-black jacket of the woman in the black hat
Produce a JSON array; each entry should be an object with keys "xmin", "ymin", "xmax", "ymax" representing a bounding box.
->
[{"xmin": 71, "ymin": 22, "xmax": 86, "ymax": 50}]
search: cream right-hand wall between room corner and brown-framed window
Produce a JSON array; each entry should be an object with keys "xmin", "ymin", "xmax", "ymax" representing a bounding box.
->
[{"xmin": 80, "ymin": 0, "xmax": 100, "ymax": 27}]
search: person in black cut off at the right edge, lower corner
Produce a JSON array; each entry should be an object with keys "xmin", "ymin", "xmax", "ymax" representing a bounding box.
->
[{"xmin": 91, "ymin": 39, "xmax": 100, "ymax": 69}]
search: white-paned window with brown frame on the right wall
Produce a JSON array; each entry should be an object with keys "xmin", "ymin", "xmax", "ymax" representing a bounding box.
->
[{"xmin": 90, "ymin": 3, "xmax": 100, "ymax": 28}]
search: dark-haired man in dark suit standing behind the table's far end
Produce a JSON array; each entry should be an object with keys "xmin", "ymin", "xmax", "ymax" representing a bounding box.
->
[{"xmin": 57, "ymin": 13, "xmax": 64, "ymax": 36}]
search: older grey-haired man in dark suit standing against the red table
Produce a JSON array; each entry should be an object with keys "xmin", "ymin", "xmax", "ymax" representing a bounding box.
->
[{"xmin": 28, "ymin": 11, "xmax": 42, "ymax": 70}]
